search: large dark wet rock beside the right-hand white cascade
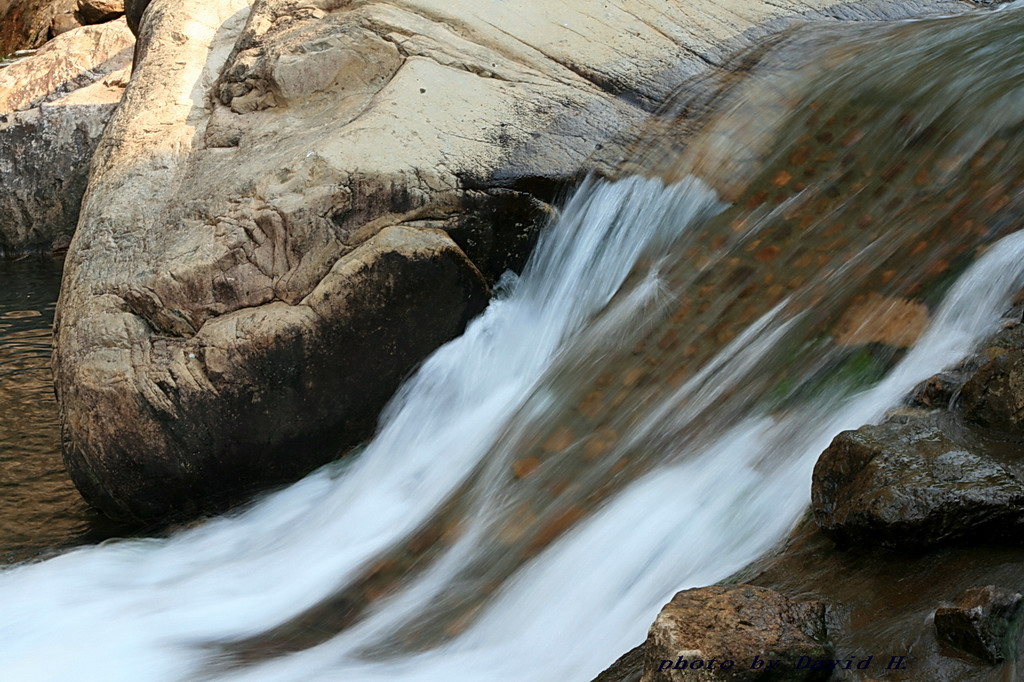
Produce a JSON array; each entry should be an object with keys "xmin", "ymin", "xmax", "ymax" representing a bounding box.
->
[{"xmin": 812, "ymin": 416, "xmax": 1024, "ymax": 547}]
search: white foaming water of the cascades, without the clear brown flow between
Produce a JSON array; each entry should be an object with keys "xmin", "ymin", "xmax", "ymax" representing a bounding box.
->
[{"xmin": 6, "ymin": 173, "xmax": 1024, "ymax": 682}]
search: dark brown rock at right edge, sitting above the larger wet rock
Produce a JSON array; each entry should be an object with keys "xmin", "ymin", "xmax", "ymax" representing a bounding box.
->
[{"xmin": 961, "ymin": 349, "xmax": 1024, "ymax": 440}]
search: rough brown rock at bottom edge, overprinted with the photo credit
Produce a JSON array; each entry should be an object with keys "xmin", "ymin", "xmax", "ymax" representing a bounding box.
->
[{"xmin": 641, "ymin": 585, "xmax": 831, "ymax": 682}]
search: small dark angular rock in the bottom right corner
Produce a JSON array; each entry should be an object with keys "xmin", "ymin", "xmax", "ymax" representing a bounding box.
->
[{"xmin": 935, "ymin": 585, "xmax": 1024, "ymax": 666}]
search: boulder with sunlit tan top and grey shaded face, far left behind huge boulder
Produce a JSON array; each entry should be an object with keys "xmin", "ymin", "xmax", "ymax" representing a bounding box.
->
[{"xmin": 0, "ymin": 20, "xmax": 134, "ymax": 255}]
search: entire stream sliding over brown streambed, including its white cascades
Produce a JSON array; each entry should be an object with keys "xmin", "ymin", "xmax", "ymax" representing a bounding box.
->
[{"xmin": 0, "ymin": 1, "xmax": 1024, "ymax": 682}]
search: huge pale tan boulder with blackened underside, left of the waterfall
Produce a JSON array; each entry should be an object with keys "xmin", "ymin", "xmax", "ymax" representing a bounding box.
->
[{"xmin": 54, "ymin": 0, "xmax": 974, "ymax": 516}]
